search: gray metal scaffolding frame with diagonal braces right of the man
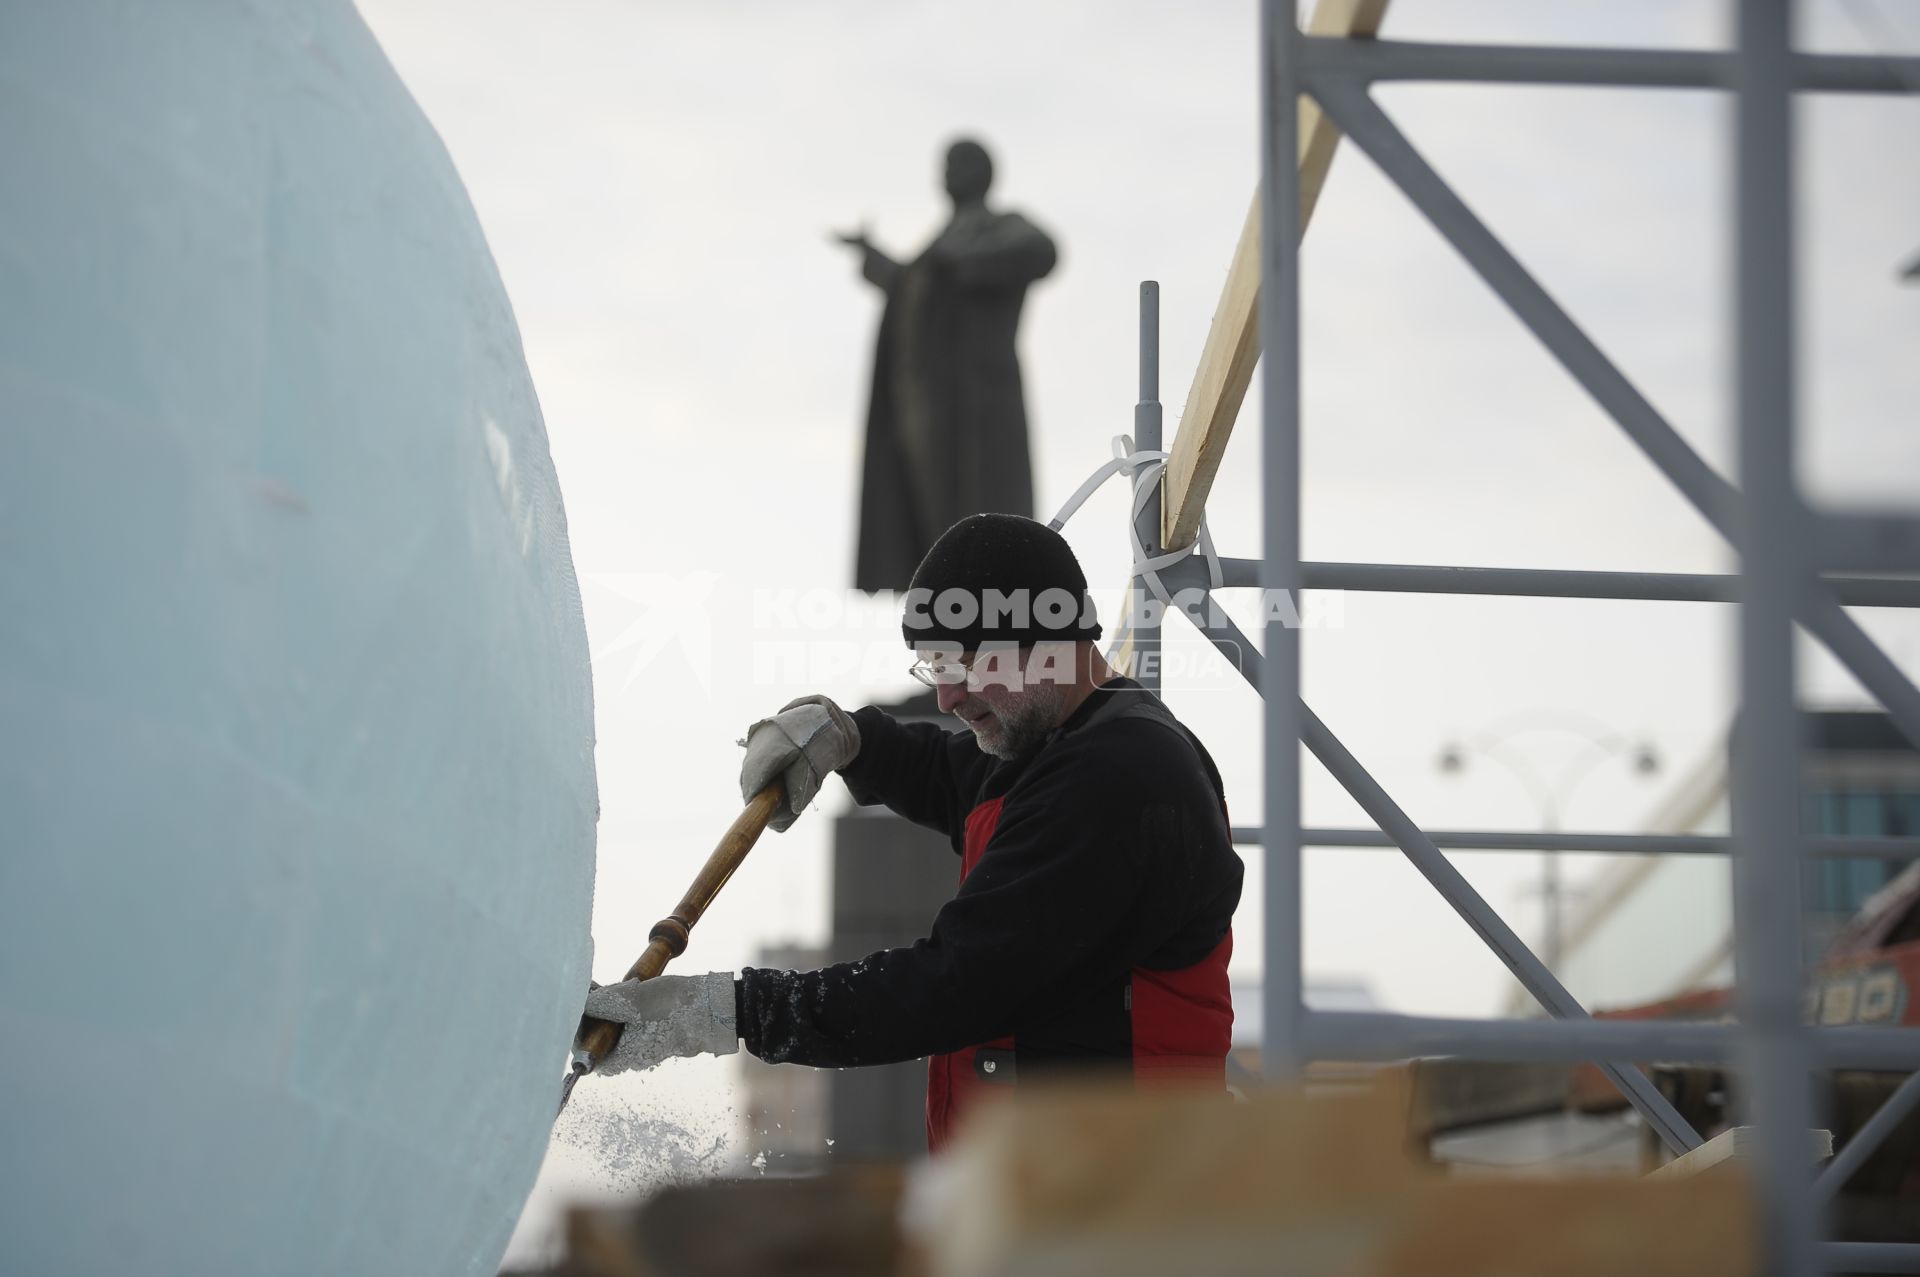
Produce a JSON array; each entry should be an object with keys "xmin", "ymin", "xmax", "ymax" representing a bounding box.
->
[{"xmin": 1127, "ymin": 0, "xmax": 1920, "ymax": 1275}]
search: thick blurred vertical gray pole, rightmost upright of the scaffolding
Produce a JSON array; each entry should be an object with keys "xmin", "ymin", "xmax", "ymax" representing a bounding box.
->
[{"xmin": 1730, "ymin": 0, "xmax": 1822, "ymax": 1277}]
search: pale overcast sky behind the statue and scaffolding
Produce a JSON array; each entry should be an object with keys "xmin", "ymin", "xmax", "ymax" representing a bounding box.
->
[{"xmin": 359, "ymin": 0, "xmax": 1920, "ymax": 1252}]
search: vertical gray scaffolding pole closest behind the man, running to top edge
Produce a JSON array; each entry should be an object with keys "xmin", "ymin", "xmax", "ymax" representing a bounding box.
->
[{"xmin": 1260, "ymin": 0, "xmax": 1306, "ymax": 1079}]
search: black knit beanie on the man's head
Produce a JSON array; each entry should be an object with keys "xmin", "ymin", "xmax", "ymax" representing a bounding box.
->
[{"xmin": 900, "ymin": 515, "xmax": 1100, "ymax": 651}]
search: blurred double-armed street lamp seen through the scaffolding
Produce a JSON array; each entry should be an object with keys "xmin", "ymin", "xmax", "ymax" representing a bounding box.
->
[{"xmin": 1436, "ymin": 711, "xmax": 1661, "ymax": 970}]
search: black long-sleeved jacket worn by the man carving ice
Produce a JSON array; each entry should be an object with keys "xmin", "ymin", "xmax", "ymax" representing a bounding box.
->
[{"xmin": 737, "ymin": 678, "xmax": 1242, "ymax": 1070}]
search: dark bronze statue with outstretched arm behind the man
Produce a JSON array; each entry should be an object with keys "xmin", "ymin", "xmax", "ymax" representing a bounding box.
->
[{"xmin": 837, "ymin": 140, "xmax": 1056, "ymax": 590}]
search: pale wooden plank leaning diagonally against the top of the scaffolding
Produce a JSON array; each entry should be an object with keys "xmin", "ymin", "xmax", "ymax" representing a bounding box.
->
[{"xmin": 1160, "ymin": 0, "xmax": 1386, "ymax": 549}]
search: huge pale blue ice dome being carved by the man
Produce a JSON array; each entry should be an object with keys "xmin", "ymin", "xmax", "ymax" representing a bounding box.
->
[{"xmin": 0, "ymin": 0, "xmax": 597, "ymax": 1275}]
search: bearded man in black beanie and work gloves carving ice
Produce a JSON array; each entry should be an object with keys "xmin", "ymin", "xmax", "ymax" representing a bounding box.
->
[{"xmin": 588, "ymin": 515, "xmax": 1240, "ymax": 1150}]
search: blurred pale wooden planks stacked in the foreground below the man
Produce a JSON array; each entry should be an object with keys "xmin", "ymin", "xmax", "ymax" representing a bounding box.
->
[{"xmin": 921, "ymin": 1085, "xmax": 1757, "ymax": 1277}]
